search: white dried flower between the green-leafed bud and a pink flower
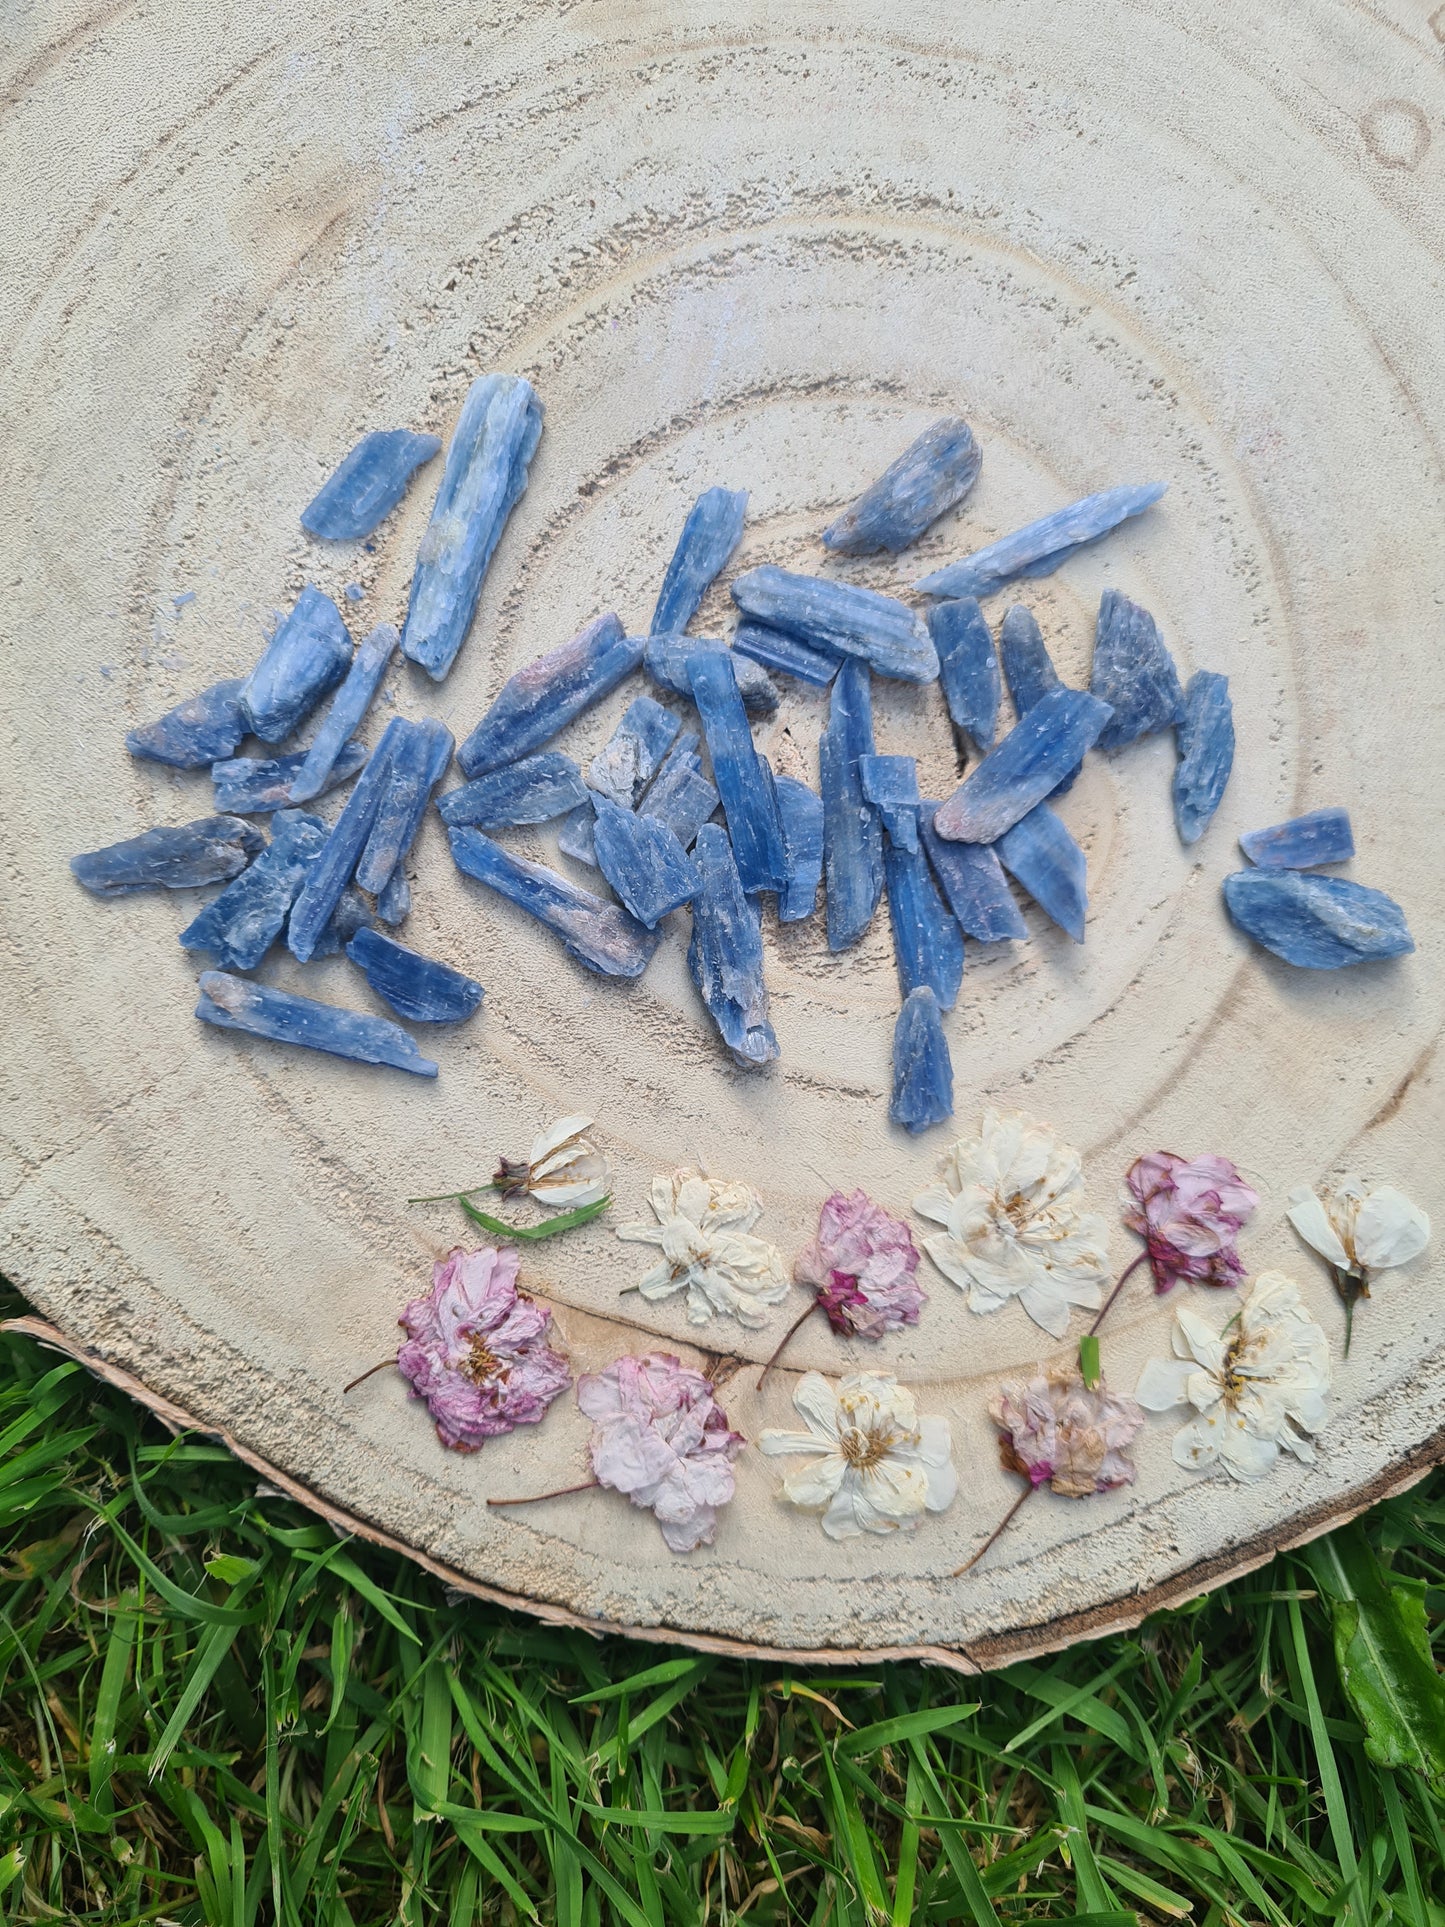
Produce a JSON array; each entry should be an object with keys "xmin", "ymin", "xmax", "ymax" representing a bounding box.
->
[{"xmin": 617, "ymin": 1170, "xmax": 788, "ymax": 1326}]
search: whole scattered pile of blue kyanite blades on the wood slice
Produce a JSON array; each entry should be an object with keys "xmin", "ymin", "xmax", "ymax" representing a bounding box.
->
[{"xmin": 71, "ymin": 376, "xmax": 1412, "ymax": 1131}]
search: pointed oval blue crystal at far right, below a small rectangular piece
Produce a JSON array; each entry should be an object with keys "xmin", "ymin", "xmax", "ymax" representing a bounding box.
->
[{"xmin": 1223, "ymin": 869, "xmax": 1414, "ymax": 969}]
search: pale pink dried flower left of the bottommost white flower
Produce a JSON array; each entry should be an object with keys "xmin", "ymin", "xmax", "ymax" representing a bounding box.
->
[{"xmin": 576, "ymin": 1351, "xmax": 744, "ymax": 1553}]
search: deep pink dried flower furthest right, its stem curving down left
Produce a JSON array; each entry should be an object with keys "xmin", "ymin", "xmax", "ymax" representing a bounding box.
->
[{"xmin": 1123, "ymin": 1150, "xmax": 1260, "ymax": 1291}]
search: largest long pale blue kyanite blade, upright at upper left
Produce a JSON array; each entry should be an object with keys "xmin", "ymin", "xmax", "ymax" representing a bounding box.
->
[{"xmin": 401, "ymin": 374, "xmax": 543, "ymax": 682}]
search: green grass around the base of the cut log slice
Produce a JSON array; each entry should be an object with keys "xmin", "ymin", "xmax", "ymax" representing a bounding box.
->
[{"xmin": 0, "ymin": 1303, "xmax": 1445, "ymax": 1927}]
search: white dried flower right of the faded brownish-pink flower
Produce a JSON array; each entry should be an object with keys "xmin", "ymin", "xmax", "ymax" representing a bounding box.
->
[{"xmin": 1135, "ymin": 1272, "xmax": 1331, "ymax": 1480}]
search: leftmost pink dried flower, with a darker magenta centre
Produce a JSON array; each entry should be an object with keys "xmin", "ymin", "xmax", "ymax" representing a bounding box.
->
[{"xmin": 397, "ymin": 1245, "xmax": 572, "ymax": 1451}]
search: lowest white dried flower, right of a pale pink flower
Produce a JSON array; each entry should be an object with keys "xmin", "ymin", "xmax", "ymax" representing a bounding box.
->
[{"xmin": 757, "ymin": 1372, "xmax": 958, "ymax": 1540}]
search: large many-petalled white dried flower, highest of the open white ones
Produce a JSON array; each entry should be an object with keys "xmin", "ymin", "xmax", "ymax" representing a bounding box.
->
[{"xmin": 913, "ymin": 1110, "xmax": 1108, "ymax": 1337}]
